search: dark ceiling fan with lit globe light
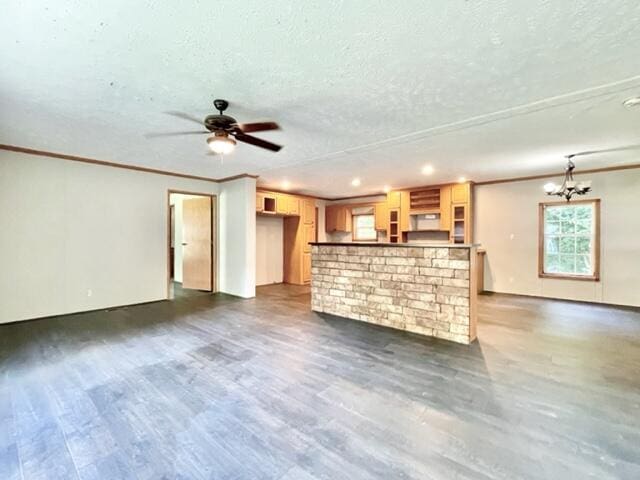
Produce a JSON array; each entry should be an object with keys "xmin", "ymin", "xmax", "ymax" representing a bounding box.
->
[{"xmin": 145, "ymin": 99, "xmax": 282, "ymax": 154}]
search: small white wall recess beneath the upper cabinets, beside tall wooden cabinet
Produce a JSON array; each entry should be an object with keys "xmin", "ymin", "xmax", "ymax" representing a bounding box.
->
[{"xmin": 256, "ymin": 215, "xmax": 284, "ymax": 285}]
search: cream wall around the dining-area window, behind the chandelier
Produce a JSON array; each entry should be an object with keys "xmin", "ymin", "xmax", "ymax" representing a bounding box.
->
[{"xmin": 474, "ymin": 169, "xmax": 640, "ymax": 306}]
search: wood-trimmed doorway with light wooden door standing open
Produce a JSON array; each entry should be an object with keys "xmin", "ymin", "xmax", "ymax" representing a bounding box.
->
[{"xmin": 167, "ymin": 190, "xmax": 217, "ymax": 299}]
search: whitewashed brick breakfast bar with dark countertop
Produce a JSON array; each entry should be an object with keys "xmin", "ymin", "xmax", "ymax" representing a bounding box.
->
[{"xmin": 311, "ymin": 242, "xmax": 477, "ymax": 344}]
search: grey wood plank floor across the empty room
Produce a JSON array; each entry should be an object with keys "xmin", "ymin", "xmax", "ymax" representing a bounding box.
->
[{"xmin": 0, "ymin": 286, "xmax": 640, "ymax": 480}]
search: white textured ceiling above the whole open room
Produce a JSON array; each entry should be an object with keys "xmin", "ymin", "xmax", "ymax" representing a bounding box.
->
[{"xmin": 0, "ymin": 0, "xmax": 640, "ymax": 197}]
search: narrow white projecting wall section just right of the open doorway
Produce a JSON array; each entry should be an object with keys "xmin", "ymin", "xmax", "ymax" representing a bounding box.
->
[{"xmin": 218, "ymin": 178, "xmax": 256, "ymax": 298}]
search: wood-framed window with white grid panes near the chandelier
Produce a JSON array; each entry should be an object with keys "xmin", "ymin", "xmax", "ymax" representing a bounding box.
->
[{"xmin": 538, "ymin": 200, "xmax": 600, "ymax": 280}]
